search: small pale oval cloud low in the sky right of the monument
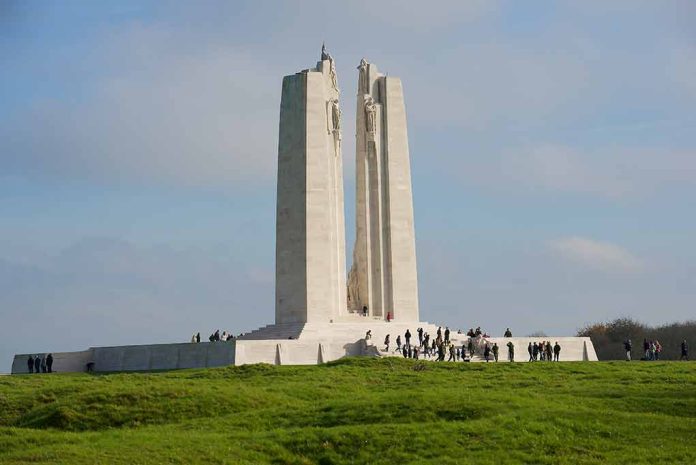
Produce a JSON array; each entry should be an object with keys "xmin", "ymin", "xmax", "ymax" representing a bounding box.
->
[{"xmin": 549, "ymin": 236, "xmax": 645, "ymax": 273}]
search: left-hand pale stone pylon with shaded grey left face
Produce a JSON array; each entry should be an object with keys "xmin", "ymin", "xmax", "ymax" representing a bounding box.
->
[{"xmin": 276, "ymin": 47, "xmax": 347, "ymax": 324}]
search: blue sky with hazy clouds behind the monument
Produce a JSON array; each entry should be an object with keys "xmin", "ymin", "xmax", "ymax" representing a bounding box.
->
[{"xmin": 0, "ymin": 0, "xmax": 696, "ymax": 371}]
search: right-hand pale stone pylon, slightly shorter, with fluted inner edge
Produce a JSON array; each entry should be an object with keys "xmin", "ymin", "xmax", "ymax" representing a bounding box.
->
[{"xmin": 348, "ymin": 59, "xmax": 419, "ymax": 322}]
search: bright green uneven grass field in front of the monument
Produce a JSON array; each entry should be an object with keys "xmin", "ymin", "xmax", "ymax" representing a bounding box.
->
[{"xmin": 0, "ymin": 358, "xmax": 696, "ymax": 465}]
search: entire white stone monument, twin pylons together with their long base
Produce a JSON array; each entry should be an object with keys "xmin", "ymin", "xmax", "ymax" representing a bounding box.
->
[{"xmin": 12, "ymin": 47, "xmax": 597, "ymax": 373}]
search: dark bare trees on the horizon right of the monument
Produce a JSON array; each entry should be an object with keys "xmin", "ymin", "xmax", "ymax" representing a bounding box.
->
[{"xmin": 578, "ymin": 318, "xmax": 696, "ymax": 360}]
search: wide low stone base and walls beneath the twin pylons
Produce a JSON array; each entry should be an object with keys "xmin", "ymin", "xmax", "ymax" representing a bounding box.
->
[{"xmin": 12, "ymin": 315, "xmax": 597, "ymax": 374}]
